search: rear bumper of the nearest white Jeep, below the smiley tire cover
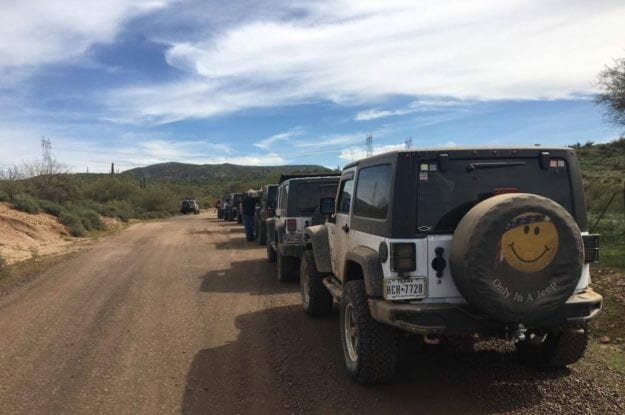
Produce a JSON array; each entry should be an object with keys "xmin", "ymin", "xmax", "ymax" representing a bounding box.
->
[{"xmin": 369, "ymin": 288, "xmax": 603, "ymax": 335}]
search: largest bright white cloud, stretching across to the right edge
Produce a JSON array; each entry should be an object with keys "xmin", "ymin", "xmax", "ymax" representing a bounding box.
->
[{"xmin": 105, "ymin": 0, "xmax": 625, "ymax": 122}]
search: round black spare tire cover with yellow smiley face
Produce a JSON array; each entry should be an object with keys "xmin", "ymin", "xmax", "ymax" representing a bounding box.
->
[{"xmin": 450, "ymin": 193, "xmax": 584, "ymax": 324}]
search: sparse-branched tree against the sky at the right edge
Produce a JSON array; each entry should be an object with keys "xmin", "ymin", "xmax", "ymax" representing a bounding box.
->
[{"xmin": 597, "ymin": 58, "xmax": 625, "ymax": 126}]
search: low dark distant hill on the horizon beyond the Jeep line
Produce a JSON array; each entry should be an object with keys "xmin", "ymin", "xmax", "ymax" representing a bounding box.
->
[{"xmin": 122, "ymin": 162, "xmax": 332, "ymax": 184}]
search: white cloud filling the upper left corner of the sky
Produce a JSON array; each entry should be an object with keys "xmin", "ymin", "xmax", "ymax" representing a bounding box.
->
[{"xmin": 0, "ymin": 0, "xmax": 170, "ymax": 70}]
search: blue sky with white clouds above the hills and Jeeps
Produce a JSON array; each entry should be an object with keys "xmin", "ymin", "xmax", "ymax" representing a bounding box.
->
[{"xmin": 0, "ymin": 0, "xmax": 625, "ymax": 172}]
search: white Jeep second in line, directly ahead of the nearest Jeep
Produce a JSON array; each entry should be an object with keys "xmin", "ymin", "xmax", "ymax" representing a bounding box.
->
[{"xmin": 266, "ymin": 176, "xmax": 339, "ymax": 282}]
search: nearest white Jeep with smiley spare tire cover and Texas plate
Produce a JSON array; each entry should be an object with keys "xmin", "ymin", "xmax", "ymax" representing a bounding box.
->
[{"xmin": 300, "ymin": 148, "xmax": 602, "ymax": 383}]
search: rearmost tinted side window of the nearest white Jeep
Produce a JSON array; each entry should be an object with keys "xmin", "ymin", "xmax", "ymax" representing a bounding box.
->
[{"xmin": 354, "ymin": 164, "xmax": 392, "ymax": 219}]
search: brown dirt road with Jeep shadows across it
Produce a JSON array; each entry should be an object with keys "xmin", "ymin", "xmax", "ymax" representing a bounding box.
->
[{"xmin": 0, "ymin": 215, "xmax": 625, "ymax": 414}]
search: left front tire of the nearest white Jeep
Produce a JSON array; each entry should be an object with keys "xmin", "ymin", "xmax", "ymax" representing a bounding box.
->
[{"xmin": 299, "ymin": 251, "xmax": 333, "ymax": 317}]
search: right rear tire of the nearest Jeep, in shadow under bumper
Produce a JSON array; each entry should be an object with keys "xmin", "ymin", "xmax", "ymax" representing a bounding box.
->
[{"xmin": 517, "ymin": 329, "xmax": 588, "ymax": 369}]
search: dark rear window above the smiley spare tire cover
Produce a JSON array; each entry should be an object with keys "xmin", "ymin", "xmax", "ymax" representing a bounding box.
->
[{"xmin": 416, "ymin": 158, "xmax": 574, "ymax": 232}]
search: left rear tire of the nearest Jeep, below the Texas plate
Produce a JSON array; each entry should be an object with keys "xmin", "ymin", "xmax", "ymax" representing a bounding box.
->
[{"xmin": 340, "ymin": 280, "xmax": 399, "ymax": 384}]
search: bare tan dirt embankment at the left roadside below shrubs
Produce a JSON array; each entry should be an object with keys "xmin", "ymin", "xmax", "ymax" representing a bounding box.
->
[{"xmin": 0, "ymin": 203, "xmax": 118, "ymax": 264}]
